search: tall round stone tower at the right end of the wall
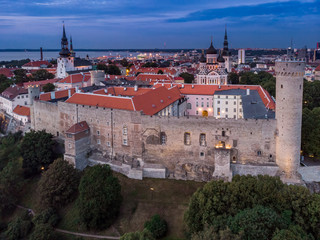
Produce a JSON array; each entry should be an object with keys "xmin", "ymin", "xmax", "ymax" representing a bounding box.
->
[{"xmin": 275, "ymin": 59, "xmax": 305, "ymax": 182}]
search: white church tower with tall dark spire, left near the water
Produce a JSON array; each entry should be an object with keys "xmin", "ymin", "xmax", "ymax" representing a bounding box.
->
[{"xmin": 57, "ymin": 24, "xmax": 74, "ymax": 78}]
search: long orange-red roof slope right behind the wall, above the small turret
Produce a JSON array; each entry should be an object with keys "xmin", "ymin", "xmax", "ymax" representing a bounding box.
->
[{"xmin": 66, "ymin": 93, "xmax": 135, "ymax": 111}]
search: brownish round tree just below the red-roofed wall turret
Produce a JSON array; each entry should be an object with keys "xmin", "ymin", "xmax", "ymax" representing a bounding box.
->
[{"xmin": 38, "ymin": 159, "xmax": 80, "ymax": 208}]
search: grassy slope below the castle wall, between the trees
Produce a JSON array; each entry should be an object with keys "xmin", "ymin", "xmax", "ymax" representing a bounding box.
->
[{"xmin": 58, "ymin": 173, "xmax": 204, "ymax": 240}]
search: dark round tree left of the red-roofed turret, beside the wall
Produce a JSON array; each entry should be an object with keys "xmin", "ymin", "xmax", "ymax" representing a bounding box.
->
[{"xmin": 20, "ymin": 130, "xmax": 55, "ymax": 173}]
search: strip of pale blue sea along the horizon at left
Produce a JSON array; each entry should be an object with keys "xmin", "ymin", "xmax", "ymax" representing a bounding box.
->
[{"xmin": 0, "ymin": 51, "xmax": 173, "ymax": 61}]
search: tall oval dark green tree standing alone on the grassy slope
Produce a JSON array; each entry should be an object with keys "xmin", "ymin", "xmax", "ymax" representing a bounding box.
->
[{"xmin": 78, "ymin": 165, "xmax": 122, "ymax": 229}]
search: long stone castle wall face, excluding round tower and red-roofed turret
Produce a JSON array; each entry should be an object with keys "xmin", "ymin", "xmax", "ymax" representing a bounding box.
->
[{"xmin": 34, "ymin": 101, "xmax": 276, "ymax": 181}]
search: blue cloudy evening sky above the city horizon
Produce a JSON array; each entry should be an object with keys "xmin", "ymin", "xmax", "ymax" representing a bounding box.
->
[{"xmin": 0, "ymin": 0, "xmax": 320, "ymax": 49}]
